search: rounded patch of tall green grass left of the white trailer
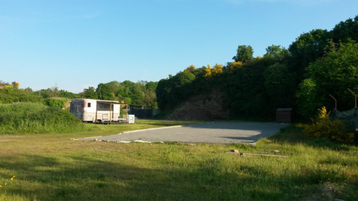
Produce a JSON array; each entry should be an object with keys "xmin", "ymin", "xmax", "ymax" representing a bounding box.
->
[{"xmin": 0, "ymin": 103, "xmax": 86, "ymax": 134}]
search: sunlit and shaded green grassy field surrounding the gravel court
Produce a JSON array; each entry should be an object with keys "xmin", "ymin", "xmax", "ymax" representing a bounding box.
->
[{"xmin": 0, "ymin": 121, "xmax": 358, "ymax": 201}]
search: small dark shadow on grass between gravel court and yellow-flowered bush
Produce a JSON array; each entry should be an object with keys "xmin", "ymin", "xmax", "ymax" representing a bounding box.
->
[{"xmin": 269, "ymin": 125, "xmax": 350, "ymax": 151}]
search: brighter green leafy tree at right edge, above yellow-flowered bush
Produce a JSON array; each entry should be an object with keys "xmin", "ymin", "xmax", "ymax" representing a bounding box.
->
[{"xmin": 297, "ymin": 41, "xmax": 358, "ymax": 116}]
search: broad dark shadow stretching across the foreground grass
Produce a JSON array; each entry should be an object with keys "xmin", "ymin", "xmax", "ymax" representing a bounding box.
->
[{"xmin": 0, "ymin": 155, "xmax": 357, "ymax": 201}]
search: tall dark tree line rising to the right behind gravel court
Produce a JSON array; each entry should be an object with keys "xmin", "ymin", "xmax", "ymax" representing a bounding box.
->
[{"xmin": 156, "ymin": 16, "xmax": 358, "ymax": 118}]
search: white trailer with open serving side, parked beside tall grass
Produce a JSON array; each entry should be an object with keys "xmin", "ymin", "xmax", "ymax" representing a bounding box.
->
[{"xmin": 70, "ymin": 98, "xmax": 122, "ymax": 123}]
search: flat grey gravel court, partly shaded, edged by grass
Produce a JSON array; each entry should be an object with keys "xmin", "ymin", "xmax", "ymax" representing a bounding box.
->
[{"xmin": 76, "ymin": 122, "xmax": 288, "ymax": 144}]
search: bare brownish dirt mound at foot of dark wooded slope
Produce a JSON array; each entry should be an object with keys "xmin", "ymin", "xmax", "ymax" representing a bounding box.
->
[{"xmin": 166, "ymin": 91, "xmax": 229, "ymax": 120}]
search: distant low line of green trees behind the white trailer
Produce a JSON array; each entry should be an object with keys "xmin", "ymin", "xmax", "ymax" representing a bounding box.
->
[{"xmin": 0, "ymin": 80, "xmax": 158, "ymax": 109}]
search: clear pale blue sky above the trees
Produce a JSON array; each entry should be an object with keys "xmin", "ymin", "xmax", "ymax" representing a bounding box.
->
[{"xmin": 0, "ymin": 0, "xmax": 358, "ymax": 93}]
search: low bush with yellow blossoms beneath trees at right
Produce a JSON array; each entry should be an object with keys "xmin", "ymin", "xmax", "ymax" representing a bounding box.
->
[{"xmin": 297, "ymin": 107, "xmax": 354, "ymax": 144}]
